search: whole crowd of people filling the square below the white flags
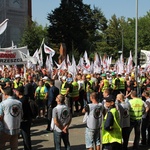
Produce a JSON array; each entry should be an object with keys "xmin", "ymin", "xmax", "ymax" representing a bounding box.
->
[{"xmin": 0, "ymin": 67, "xmax": 150, "ymax": 150}]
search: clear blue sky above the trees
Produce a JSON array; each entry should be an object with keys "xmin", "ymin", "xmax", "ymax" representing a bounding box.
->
[{"xmin": 32, "ymin": 0, "xmax": 150, "ymax": 26}]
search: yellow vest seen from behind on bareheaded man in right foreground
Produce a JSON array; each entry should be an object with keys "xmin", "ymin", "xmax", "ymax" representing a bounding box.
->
[{"xmin": 129, "ymin": 98, "xmax": 143, "ymax": 120}]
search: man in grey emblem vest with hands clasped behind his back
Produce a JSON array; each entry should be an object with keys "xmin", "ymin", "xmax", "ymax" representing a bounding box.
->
[{"xmin": 51, "ymin": 94, "xmax": 71, "ymax": 150}]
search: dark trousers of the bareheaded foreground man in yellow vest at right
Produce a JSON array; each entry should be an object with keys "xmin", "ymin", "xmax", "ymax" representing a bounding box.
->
[{"xmin": 129, "ymin": 120, "xmax": 141, "ymax": 150}]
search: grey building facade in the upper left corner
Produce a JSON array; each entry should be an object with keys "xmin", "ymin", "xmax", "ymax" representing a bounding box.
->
[{"xmin": 0, "ymin": 0, "xmax": 31, "ymax": 47}]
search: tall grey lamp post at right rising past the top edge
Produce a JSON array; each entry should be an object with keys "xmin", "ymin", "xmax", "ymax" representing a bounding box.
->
[{"xmin": 135, "ymin": 0, "xmax": 138, "ymax": 82}]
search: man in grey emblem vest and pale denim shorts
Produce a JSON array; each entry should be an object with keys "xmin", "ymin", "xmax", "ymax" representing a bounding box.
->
[{"xmin": 82, "ymin": 92, "xmax": 103, "ymax": 150}]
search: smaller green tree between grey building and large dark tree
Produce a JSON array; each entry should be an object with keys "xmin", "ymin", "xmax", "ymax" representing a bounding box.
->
[{"xmin": 20, "ymin": 22, "xmax": 47, "ymax": 55}]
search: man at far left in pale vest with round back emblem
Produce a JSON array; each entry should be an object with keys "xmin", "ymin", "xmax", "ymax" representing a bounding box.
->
[{"xmin": 0, "ymin": 88, "xmax": 22, "ymax": 150}]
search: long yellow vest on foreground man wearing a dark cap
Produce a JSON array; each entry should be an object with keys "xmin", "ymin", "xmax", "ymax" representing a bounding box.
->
[{"xmin": 102, "ymin": 108, "xmax": 122, "ymax": 144}]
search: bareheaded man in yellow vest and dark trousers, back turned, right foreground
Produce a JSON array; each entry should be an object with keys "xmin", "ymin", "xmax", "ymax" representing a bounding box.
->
[{"xmin": 129, "ymin": 91, "xmax": 148, "ymax": 150}]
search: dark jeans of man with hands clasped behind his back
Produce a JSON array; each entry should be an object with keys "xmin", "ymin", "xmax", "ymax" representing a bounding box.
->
[{"xmin": 54, "ymin": 130, "xmax": 70, "ymax": 150}]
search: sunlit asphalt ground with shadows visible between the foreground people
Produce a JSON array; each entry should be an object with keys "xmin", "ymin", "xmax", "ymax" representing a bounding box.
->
[{"xmin": 5, "ymin": 113, "xmax": 150, "ymax": 150}]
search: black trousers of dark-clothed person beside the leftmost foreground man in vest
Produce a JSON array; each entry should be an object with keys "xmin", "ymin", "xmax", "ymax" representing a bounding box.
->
[{"xmin": 21, "ymin": 120, "xmax": 31, "ymax": 150}]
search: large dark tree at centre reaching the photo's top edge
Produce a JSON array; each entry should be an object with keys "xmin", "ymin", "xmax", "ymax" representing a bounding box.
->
[{"xmin": 47, "ymin": 0, "xmax": 107, "ymax": 54}]
